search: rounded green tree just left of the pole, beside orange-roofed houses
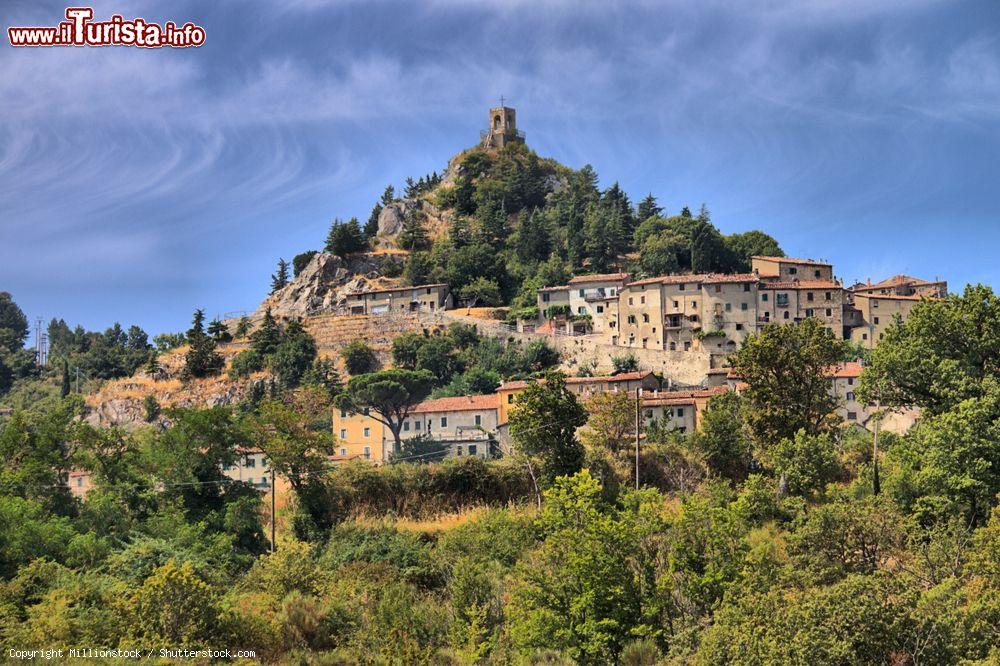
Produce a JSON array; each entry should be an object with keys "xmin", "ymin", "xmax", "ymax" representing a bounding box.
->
[{"xmin": 508, "ymin": 373, "xmax": 587, "ymax": 481}]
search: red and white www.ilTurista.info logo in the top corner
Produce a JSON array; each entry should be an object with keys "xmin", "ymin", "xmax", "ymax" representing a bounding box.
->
[{"xmin": 7, "ymin": 7, "xmax": 205, "ymax": 49}]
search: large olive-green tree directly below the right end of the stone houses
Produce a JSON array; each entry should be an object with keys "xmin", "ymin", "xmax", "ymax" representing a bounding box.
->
[{"xmin": 731, "ymin": 317, "xmax": 847, "ymax": 448}]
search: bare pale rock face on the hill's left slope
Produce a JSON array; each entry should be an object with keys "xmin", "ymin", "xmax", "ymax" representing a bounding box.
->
[{"xmin": 253, "ymin": 253, "xmax": 401, "ymax": 319}]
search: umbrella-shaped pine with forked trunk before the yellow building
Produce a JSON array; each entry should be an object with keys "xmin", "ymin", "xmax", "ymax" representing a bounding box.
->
[{"xmin": 336, "ymin": 368, "xmax": 435, "ymax": 455}]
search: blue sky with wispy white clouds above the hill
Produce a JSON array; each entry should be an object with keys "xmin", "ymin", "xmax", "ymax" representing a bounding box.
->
[{"xmin": 0, "ymin": 0, "xmax": 1000, "ymax": 334}]
